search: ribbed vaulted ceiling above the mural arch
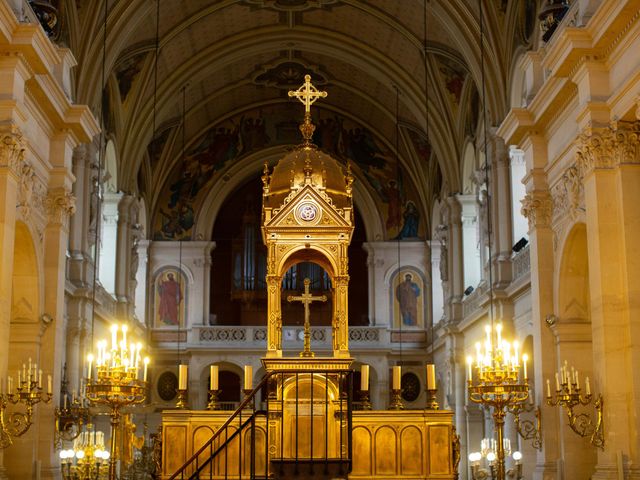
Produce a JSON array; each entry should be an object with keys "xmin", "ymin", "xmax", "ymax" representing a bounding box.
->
[{"xmin": 64, "ymin": 0, "xmax": 536, "ymax": 238}]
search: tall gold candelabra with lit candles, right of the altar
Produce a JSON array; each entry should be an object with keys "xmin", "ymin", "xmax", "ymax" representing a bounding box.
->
[{"xmin": 467, "ymin": 324, "xmax": 529, "ymax": 480}]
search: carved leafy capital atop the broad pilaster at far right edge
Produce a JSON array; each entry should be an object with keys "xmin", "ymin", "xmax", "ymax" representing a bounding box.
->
[{"xmin": 576, "ymin": 121, "xmax": 640, "ymax": 177}]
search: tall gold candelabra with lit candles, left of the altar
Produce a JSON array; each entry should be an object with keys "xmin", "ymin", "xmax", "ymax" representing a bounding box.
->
[{"xmin": 86, "ymin": 325, "xmax": 149, "ymax": 480}]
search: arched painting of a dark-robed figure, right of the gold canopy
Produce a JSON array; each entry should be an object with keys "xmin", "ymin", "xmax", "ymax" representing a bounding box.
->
[{"xmin": 391, "ymin": 268, "xmax": 427, "ymax": 329}]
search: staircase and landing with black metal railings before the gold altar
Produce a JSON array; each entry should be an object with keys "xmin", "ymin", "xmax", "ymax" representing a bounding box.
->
[{"xmin": 164, "ymin": 370, "xmax": 353, "ymax": 480}]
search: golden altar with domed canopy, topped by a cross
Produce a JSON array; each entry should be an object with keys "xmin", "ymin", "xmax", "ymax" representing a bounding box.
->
[{"xmin": 162, "ymin": 75, "xmax": 457, "ymax": 480}]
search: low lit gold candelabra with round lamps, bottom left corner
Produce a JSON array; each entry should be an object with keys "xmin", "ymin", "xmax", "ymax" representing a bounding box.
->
[{"xmin": 60, "ymin": 424, "xmax": 110, "ymax": 480}]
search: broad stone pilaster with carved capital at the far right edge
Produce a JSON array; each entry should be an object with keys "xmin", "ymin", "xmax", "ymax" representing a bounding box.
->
[{"xmin": 576, "ymin": 122, "xmax": 640, "ymax": 480}]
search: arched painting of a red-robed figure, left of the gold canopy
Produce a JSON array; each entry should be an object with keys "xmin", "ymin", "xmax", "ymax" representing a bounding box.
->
[{"xmin": 154, "ymin": 267, "xmax": 187, "ymax": 328}]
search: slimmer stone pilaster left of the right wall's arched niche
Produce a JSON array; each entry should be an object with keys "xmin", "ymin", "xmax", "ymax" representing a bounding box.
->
[{"xmin": 522, "ymin": 136, "xmax": 560, "ymax": 480}]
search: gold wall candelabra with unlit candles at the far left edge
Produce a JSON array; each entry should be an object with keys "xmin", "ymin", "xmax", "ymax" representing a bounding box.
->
[{"xmin": 0, "ymin": 359, "xmax": 53, "ymax": 449}]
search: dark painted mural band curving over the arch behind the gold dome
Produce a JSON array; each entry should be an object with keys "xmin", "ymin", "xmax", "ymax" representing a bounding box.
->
[{"xmin": 153, "ymin": 104, "xmax": 423, "ymax": 240}]
